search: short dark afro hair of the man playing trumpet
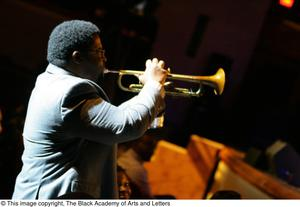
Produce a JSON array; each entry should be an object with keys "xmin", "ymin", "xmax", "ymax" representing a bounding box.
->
[{"xmin": 47, "ymin": 20, "xmax": 100, "ymax": 67}]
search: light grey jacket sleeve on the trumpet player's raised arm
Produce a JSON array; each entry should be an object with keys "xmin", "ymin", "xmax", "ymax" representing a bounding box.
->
[{"xmin": 61, "ymin": 81, "xmax": 164, "ymax": 144}]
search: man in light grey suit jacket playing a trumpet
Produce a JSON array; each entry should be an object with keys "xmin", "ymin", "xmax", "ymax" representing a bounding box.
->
[{"xmin": 13, "ymin": 20, "xmax": 168, "ymax": 199}]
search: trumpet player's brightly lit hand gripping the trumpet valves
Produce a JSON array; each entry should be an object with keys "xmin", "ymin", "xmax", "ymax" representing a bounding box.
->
[{"xmin": 139, "ymin": 58, "xmax": 169, "ymax": 85}]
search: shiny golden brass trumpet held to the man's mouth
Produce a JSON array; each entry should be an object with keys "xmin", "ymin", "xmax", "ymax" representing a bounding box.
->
[{"xmin": 104, "ymin": 68, "xmax": 225, "ymax": 97}]
